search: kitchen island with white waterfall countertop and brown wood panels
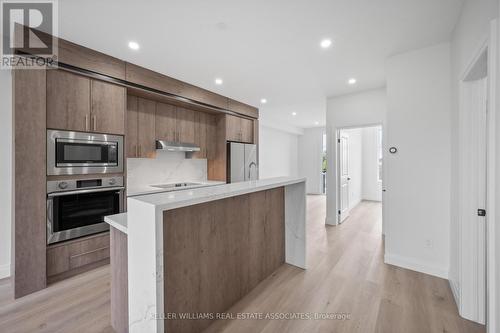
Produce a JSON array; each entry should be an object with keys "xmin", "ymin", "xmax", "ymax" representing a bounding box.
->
[{"xmin": 106, "ymin": 178, "xmax": 306, "ymax": 332}]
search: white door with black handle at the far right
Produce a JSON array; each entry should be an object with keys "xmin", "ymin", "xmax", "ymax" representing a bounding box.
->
[{"xmin": 459, "ymin": 78, "xmax": 488, "ymax": 324}]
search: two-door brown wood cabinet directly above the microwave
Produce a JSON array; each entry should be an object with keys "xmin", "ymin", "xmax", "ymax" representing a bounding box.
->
[{"xmin": 47, "ymin": 70, "xmax": 126, "ymax": 135}]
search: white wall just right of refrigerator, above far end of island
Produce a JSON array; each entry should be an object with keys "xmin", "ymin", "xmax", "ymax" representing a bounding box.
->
[{"xmin": 259, "ymin": 124, "xmax": 298, "ymax": 179}]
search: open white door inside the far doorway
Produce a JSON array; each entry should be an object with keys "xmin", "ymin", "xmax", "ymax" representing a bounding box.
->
[{"xmin": 338, "ymin": 131, "xmax": 351, "ymax": 223}]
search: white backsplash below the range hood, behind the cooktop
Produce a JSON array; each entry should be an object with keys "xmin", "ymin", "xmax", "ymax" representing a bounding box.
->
[{"xmin": 127, "ymin": 151, "xmax": 207, "ymax": 188}]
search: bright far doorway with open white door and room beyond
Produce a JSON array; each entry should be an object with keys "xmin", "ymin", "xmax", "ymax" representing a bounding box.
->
[{"xmin": 336, "ymin": 125, "xmax": 383, "ymax": 224}]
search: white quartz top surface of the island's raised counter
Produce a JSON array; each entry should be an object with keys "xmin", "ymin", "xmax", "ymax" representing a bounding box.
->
[{"xmin": 133, "ymin": 177, "xmax": 306, "ymax": 211}]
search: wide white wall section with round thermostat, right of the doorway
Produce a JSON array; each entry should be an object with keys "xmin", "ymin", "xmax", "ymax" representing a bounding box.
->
[{"xmin": 384, "ymin": 44, "xmax": 451, "ymax": 278}]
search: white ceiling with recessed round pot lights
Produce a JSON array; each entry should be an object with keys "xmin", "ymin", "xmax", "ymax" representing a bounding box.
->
[{"xmin": 59, "ymin": 0, "xmax": 463, "ymax": 127}]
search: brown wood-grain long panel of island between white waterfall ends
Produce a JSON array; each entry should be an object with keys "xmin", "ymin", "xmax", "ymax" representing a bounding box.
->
[{"xmin": 163, "ymin": 187, "xmax": 285, "ymax": 333}]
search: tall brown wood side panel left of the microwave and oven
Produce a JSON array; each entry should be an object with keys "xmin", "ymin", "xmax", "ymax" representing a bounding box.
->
[{"xmin": 12, "ymin": 70, "xmax": 47, "ymax": 298}]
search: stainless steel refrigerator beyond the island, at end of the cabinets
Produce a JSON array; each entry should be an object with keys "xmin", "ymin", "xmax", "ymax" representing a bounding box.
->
[{"xmin": 227, "ymin": 142, "xmax": 259, "ymax": 183}]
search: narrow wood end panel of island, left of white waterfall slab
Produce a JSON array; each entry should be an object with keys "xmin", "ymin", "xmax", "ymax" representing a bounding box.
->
[{"xmin": 110, "ymin": 227, "xmax": 128, "ymax": 333}]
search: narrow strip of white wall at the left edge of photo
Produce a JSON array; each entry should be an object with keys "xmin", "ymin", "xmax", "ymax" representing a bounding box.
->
[{"xmin": 0, "ymin": 70, "xmax": 12, "ymax": 279}]
